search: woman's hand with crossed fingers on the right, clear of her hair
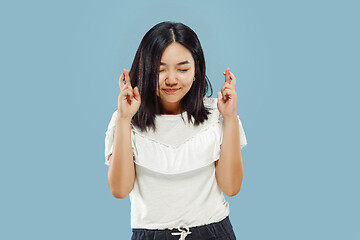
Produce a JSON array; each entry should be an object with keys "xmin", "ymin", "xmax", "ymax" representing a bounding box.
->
[{"xmin": 217, "ymin": 68, "xmax": 237, "ymax": 118}]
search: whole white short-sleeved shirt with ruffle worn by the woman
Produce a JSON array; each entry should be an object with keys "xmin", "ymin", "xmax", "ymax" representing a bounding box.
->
[{"xmin": 105, "ymin": 97, "xmax": 247, "ymax": 229}]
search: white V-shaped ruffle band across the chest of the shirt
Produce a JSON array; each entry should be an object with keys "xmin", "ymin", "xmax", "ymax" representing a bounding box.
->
[{"xmin": 134, "ymin": 115, "xmax": 221, "ymax": 174}]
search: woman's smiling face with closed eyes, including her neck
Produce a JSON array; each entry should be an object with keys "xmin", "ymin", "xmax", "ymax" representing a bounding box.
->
[{"xmin": 157, "ymin": 42, "xmax": 195, "ymax": 114}]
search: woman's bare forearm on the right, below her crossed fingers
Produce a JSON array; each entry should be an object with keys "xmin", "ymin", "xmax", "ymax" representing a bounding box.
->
[{"xmin": 216, "ymin": 116, "xmax": 243, "ymax": 196}]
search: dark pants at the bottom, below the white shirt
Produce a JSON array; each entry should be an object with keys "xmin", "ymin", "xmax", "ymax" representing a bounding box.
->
[{"xmin": 131, "ymin": 216, "xmax": 236, "ymax": 240}]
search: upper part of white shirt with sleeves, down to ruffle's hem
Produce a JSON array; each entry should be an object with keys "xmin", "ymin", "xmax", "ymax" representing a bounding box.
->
[{"xmin": 105, "ymin": 98, "xmax": 247, "ymax": 170}]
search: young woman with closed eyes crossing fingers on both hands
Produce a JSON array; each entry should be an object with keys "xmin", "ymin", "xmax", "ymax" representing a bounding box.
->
[{"xmin": 105, "ymin": 22, "xmax": 247, "ymax": 240}]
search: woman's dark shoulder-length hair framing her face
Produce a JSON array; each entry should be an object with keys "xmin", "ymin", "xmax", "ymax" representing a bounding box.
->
[{"xmin": 130, "ymin": 21, "xmax": 213, "ymax": 131}]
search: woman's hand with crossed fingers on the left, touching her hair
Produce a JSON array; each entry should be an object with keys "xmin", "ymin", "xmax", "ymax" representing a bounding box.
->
[{"xmin": 118, "ymin": 69, "xmax": 141, "ymax": 121}]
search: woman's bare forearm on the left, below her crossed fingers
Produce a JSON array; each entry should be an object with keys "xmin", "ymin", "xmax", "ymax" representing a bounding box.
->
[{"xmin": 108, "ymin": 118, "xmax": 135, "ymax": 198}]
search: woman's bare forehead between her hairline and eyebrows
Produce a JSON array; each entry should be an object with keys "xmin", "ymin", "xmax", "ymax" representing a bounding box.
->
[{"xmin": 161, "ymin": 42, "xmax": 194, "ymax": 65}]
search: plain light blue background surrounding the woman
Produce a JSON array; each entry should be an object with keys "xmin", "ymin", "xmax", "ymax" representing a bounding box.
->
[{"xmin": 0, "ymin": 0, "xmax": 360, "ymax": 240}]
